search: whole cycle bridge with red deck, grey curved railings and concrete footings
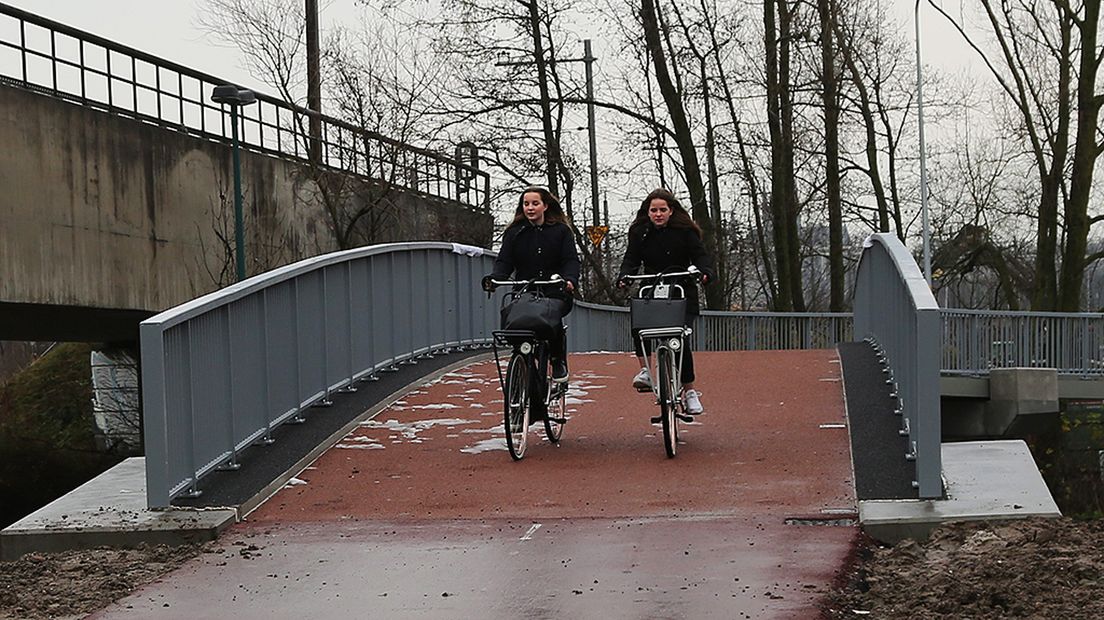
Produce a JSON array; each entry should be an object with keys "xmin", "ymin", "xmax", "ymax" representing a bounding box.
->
[{"xmin": 0, "ymin": 240, "xmax": 1058, "ymax": 618}]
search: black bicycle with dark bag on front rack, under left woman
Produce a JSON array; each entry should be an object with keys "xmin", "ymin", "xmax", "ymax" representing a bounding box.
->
[{"xmin": 490, "ymin": 276, "xmax": 567, "ymax": 461}]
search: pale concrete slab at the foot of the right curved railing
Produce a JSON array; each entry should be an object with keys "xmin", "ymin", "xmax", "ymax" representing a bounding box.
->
[{"xmin": 859, "ymin": 440, "xmax": 1062, "ymax": 544}]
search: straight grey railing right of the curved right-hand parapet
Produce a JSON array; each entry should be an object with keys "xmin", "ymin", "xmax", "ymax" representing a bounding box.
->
[{"xmin": 941, "ymin": 309, "xmax": 1104, "ymax": 377}]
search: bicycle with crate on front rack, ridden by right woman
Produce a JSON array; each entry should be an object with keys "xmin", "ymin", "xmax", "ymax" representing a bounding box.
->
[{"xmin": 624, "ymin": 265, "xmax": 701, "ymax": 458}]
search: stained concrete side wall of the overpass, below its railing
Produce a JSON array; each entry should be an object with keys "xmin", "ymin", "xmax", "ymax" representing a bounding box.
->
[{"xmin": 0, "ymin": 86, "xmax": 492, "ymax": 311}]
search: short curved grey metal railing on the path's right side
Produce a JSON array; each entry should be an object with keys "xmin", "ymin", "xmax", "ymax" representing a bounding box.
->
[{"xmin": 854, "ymin": 233, "xmax": 943, "ymax": 499}]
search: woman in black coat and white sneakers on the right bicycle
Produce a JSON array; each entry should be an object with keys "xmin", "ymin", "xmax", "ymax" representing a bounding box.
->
[{"xmin": 618, "ymin": 189, "xmax": 715, "ymax": 415}]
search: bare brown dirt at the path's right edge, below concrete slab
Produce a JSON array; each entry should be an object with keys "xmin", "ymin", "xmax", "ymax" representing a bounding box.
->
[{"xmin": 825, "ymin": 519, "xmax": 1104, "ymax": 619}]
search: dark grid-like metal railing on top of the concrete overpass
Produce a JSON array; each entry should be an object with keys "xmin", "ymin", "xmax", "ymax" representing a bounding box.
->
[{"xmin": 0, "ymin": 3, "xmax": 490, "ymax": 212}]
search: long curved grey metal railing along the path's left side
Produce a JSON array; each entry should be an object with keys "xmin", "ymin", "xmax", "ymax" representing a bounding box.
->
[{"xmin": 140, "ymin": 243, "xmax": 497, "ymax": 507}]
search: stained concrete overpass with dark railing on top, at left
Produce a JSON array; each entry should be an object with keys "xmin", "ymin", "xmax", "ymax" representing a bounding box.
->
[{"xmin": 0, "ymin": 4, "xmax": 492, "ymax": 341}]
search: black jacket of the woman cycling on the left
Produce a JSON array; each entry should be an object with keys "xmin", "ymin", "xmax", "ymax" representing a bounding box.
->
[{"xmin": 491, "ymin": 221, "xmax": 578, "ymax": 299}]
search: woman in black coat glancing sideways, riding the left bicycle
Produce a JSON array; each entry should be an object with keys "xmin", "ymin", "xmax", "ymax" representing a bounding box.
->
[{"xmin": 482, "ymin": 188, "xmax": 578, "ymax": 383}]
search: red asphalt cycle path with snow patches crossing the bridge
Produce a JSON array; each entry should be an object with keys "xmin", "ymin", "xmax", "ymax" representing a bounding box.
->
[{"xmin": 94, "ymin": 351, "xmax": 858, "ymax": 620}]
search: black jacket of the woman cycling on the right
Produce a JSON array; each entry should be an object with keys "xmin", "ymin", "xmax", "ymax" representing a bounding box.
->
[{"xmin": 617, "ymin": 222, "xmax": 715, "ymax": 314}]
